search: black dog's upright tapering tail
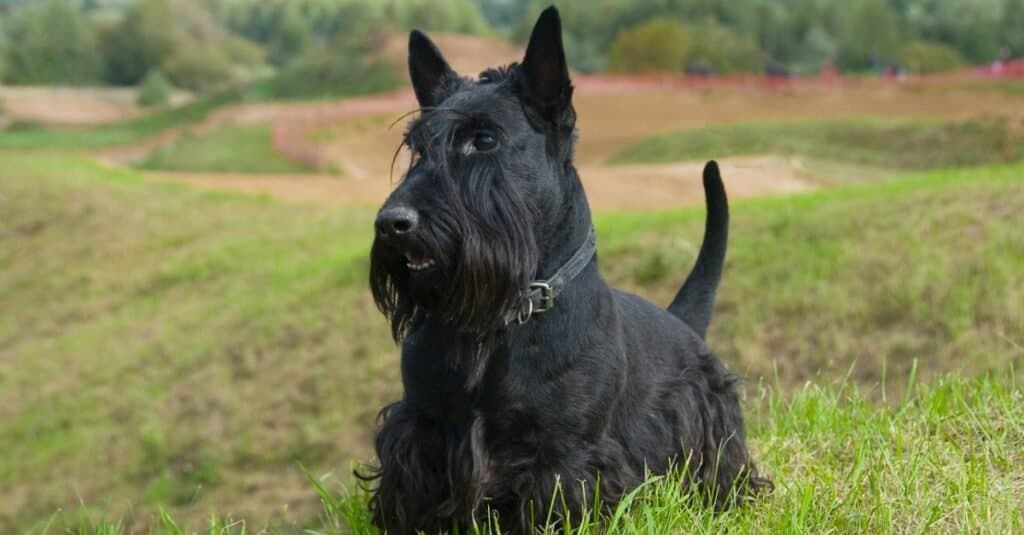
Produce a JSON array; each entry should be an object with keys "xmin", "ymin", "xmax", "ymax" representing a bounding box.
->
[{"xmin": 669, "ymin": 160, "xmax": 729, "ymax": 338}]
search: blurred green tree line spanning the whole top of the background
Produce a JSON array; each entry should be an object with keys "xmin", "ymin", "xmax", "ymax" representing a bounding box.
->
[{"xmin": 0, "ymin": 0, "xmax": 1024, "ymax": 91}]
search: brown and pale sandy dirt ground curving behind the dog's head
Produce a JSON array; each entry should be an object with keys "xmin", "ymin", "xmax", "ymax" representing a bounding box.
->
[{"xmin": 94, "ymin": 56, "xmax": 1024, "ymax": 209}]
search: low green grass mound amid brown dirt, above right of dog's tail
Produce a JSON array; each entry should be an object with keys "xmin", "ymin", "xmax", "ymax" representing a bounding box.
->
[{"xmin": 611, "ymin": 118, "xmax": 1024, "ymax": 169}]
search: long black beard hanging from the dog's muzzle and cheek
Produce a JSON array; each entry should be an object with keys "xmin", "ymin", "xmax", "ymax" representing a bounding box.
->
[{"xmin": 370, "ymin": 155, "xmax": 539, "ymax": 384}]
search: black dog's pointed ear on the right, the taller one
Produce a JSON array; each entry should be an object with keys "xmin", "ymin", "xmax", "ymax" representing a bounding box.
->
[{"xmin": 521, "ymin": 6, "xmax": 572, "ymax": 128}]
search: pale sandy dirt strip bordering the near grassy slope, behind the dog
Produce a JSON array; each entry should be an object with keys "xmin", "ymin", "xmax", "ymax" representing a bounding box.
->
[{"xmin": 146, "ymin": 156, "xmax": 821, "ymax": 210}]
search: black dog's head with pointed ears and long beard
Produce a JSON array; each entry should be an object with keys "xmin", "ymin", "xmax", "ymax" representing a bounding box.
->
[{"xmin": 370, "ymin": 7, "xmax": 575, "ymax": 339}]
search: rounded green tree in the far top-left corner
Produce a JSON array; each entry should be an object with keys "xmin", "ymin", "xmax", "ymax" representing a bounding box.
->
[{"xmin": 2, "ymin": 0, "xmax": 100, "ymax": 84}]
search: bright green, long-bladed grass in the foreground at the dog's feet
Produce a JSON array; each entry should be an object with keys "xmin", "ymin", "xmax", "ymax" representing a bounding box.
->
[{"xmin": 29, "ymin": 374, "xmax": 1024, "ymax": 535}]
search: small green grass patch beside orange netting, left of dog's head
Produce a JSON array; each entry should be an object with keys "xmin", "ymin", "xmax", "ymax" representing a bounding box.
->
[{"xmin": 138, "ymin": 125, "xmax": 313, "ymax": 173}]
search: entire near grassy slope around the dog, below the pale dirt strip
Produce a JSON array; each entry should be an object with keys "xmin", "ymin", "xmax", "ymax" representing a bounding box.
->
[{"xmin": 0, "ymin": 152, "xmax": 1024, "ymax": 533}]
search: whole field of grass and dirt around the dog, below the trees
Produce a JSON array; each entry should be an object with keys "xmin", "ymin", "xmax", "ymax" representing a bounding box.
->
[{"xmin": 0, "ymin": 59, "xmax": 1024, "ymax": 533}]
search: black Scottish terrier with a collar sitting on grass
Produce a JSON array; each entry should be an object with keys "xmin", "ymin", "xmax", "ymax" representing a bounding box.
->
[{"xmin": 364, "ymin": 7, "xmax": 770, "ymax": 534}]
